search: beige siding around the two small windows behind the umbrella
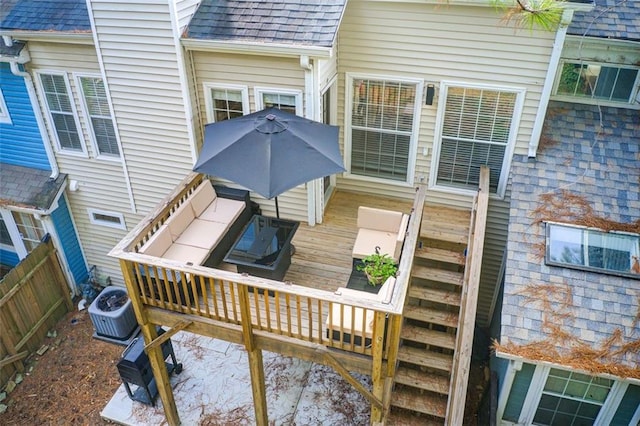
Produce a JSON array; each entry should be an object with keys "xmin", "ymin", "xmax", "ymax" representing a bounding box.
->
[{"xmin": 192, "ymin": 52, "xmax": 307, "ymax": 221}]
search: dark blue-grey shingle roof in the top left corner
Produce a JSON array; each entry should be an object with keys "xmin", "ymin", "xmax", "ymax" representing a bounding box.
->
[{"xmin": 0, "ymin": 0, "xmax": 91, "ymax": 32}]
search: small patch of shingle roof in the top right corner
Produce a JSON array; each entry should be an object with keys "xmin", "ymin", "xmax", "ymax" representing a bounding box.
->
[{"xmin": 567, "ymin": 0, "xmax": 640, "ymax": 41}]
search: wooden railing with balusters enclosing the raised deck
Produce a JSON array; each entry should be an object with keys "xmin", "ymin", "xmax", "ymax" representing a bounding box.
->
[{"xmin": 110, "ymin": 173, "xmax": 425, "ymax": 360}]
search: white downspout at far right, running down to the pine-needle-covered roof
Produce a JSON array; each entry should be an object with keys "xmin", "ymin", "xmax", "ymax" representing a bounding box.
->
[{"xmin": 529, "ymin": 9, "xmax": 573, "ymax": 158}]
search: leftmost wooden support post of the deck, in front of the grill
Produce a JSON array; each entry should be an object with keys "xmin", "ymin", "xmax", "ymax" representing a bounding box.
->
[{"xmin": 120, "ymin": 260, "xmax": 180, "ymax": 426}]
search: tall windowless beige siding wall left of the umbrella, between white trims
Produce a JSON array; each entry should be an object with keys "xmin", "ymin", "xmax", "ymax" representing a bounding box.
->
[{"xmin": 90, "ymin": 0, "xmax": 193, "ymax": 215}]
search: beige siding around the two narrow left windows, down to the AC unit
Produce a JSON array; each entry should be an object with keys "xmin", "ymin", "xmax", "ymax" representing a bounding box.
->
[{"xmin": 27, "ymin": 41, "xmax": 134, "ymax": 283}]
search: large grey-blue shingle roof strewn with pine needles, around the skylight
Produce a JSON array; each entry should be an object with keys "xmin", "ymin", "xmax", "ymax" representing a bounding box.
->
[{"xmin": 501, "ymin": 102, "xmax": 640, "ymax": 372}]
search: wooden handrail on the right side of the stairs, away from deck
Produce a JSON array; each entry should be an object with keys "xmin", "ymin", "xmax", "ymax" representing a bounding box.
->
[{"xmin": 445, "ymin": 166, "xmax": 489, "ymax": 426}]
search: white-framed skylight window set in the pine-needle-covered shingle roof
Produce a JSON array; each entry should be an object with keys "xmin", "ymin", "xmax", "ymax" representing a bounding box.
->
[{"xmin": 546, "ymin": 223, "xmax": 640, "ymax": 279}]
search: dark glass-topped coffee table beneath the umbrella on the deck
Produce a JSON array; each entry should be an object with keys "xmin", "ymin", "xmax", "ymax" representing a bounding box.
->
[{"xmin": 224, "ymin": 215, "xmax": 299, "ymax": 281}]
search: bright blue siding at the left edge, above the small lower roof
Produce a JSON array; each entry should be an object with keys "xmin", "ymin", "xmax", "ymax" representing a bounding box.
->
[{"xmin": 0, "ymin": 63, "xmax": 51, "ymax": 170}]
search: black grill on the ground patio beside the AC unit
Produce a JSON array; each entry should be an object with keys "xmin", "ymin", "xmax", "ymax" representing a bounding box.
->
[{"xmin": 117, "ymin": 329, "xmax": 182, "ymax": 406}]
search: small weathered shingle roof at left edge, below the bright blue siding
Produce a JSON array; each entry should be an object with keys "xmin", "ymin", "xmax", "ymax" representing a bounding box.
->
[{"xmin": 0, "ymin": 164, "xmax": 67, "ymax": 210}]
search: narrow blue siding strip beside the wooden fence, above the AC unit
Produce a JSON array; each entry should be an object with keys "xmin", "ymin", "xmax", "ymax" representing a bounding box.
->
[{"xmin": 51, "ymin": 196, "xmax": 88, "ymax": 284}]
